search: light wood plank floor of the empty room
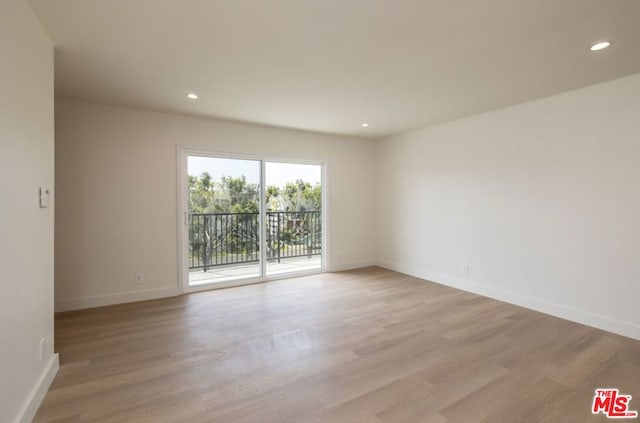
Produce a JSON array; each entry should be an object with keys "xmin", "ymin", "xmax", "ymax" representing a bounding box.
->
[{"xmin": 35, "ymin": 268, "xmax": 640, "ymax": 423}]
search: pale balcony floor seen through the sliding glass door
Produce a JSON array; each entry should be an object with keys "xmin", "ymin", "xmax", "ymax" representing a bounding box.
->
[{"xmin": 189, "ymin": 256, "xmax": 322, "ymax": 286}]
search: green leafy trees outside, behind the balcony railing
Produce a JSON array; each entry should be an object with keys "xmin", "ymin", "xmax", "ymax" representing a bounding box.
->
[{"xmin": 188, "ymin": 172, "xmax": 322, "ymax": 271}]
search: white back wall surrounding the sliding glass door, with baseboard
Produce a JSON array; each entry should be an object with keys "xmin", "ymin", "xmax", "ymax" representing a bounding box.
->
[{"xmin": 55, "ymin": 99, "xmax": 375, "ymax": 310}]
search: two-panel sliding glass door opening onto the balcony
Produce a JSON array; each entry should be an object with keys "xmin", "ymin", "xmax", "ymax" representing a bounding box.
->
[{"xmin": 180, "ymin": 150, "xmax": 324, "ymax": 290}]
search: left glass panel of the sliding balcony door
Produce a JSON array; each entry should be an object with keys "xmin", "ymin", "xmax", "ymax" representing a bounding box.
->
[{"xmin": 187, "ymin": 154, "xmax": 262, "ymax": 286}]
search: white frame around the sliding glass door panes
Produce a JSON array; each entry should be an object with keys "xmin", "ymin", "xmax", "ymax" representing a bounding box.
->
[{"xmin": 176, "ymin": 146, "xmax": 329, "ymax": 293}]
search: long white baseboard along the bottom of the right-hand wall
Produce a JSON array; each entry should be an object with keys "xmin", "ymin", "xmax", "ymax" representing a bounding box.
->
[{"xmin": 376, "ymin": 260, "xmax": 640, "ymax": 340}]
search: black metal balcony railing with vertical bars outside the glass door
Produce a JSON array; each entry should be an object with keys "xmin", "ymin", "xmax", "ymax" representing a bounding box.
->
[{"xmin": 189, "ymin": 211, "xmax": 322, "ymax": 272}]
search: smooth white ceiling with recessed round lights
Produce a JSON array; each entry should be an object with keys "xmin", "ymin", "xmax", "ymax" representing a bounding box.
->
[{"xmin": 31, "ymin": 0, "xmax": 640, "ymax": 137}]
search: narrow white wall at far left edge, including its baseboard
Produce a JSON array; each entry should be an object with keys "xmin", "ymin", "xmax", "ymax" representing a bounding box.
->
[{"xmin": 0, "ymin": 0, "xmax": 58, "ymax": 422}]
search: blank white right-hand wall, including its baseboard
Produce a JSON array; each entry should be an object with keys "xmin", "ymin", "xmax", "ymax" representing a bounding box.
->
[{"xmin": 376, "ymin": 74, "xmax": 640, "ymax": 338}]
